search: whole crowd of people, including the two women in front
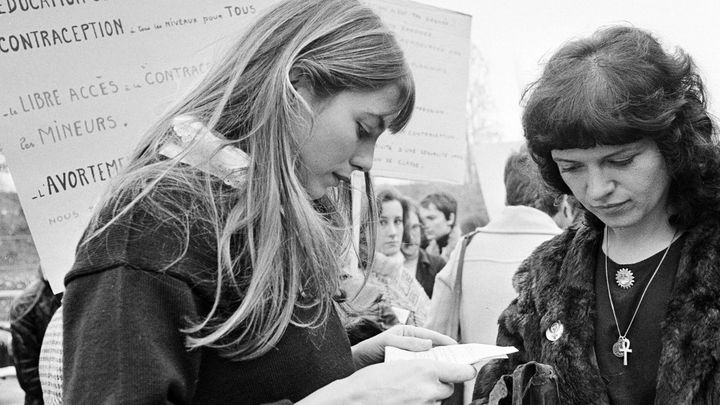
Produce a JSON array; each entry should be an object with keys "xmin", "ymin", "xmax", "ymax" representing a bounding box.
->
[{"xmin": 2, "ymin": 0, "xmax": 720, "ymax": 405}]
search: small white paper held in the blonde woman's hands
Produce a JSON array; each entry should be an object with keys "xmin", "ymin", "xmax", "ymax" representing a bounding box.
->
[{"xmin": 385, "ymin": 343, "xmax": 517, "ymax": 364}]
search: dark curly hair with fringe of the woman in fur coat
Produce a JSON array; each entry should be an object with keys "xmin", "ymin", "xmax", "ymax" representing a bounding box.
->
[{"xmin": 523, "ymin": 26, "xmax": 720, "ymax": 227}]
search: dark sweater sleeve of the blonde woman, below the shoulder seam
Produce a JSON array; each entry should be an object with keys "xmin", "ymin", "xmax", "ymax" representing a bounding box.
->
[{"xmin": 62, "ymin": 266, "xmax": 200, "ymax": 404}]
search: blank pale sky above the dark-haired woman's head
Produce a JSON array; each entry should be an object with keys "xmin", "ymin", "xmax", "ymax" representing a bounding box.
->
[{"xmin": 410, "ymin": 0, "xmax": 720, "ymax": 140}]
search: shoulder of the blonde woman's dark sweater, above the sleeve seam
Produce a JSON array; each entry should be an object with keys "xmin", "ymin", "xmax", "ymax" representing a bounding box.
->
[{"xmin": 65, "ymin": 178, "xmax": 222, "ymax": 284}]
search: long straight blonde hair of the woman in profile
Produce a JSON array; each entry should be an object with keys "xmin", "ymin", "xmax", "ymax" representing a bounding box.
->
[{"xmin": 86, "ymin": 0, "xmax": 415, "ymax": 360}]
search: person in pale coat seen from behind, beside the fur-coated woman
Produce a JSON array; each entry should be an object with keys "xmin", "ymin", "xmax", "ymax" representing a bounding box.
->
[{"xmin": 425, "ymin": 148, "xmax": 561, "ymax": 398}]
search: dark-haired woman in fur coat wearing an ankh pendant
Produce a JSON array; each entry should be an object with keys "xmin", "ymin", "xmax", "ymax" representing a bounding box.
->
[{"xmin": 474, "ymin": 26, "xmax": 720, "ymax": 404}]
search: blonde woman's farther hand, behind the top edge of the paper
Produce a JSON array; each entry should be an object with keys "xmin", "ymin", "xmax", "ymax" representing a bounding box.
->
[{"xmin": 352, "ymin": 325, "xmax": 457, "ymax": 369}]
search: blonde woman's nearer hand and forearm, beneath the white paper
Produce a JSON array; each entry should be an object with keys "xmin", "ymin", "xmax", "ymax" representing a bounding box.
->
[{"xmin": 297, "ymin": 360, "xmax": 476, "ymax": 405}]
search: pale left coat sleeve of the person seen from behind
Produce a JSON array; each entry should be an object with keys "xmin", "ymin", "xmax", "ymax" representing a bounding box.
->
[{"xmin": 425, "ymin": 248, "xmax": 460, "ymax": 340}]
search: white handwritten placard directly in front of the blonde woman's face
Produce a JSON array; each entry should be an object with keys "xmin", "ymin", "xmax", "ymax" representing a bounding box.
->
[{"xmin": 366, "ymin": 0, "xmax": 471, "ymax": 184}]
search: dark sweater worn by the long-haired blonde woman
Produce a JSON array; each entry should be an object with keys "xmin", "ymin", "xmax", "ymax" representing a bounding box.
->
[{"xmin": 63, "ymin": 200, "xmax": 354, "ymax": 404}]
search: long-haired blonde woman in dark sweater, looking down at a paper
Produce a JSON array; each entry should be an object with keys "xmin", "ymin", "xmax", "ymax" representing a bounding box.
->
[{"xmin": 63, "ymin": 0, "xmax": 474, "ymax": 404}]
